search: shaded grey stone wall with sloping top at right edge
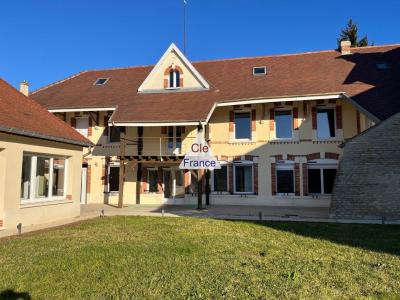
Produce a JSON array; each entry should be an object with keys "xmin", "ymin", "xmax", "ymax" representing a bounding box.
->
[{"xmin": 330, "ymin": 113, "xmax": 400, "ymax": 220}]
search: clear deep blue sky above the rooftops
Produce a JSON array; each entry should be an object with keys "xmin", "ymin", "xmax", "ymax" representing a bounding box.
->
[{"xmin": 0, "ymin": 0, "xmax": 400, "ymax": 90}]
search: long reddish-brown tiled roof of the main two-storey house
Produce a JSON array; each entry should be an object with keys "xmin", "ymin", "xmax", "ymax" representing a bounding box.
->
[{"xmin": 32, "ymin": 45, "xmax": 400, "ymax": 122}]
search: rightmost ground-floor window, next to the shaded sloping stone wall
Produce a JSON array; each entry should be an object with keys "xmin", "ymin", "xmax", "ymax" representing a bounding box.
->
[{"xmin": 308, "ymin": 164, "xmax": 337, "ymax": 194}]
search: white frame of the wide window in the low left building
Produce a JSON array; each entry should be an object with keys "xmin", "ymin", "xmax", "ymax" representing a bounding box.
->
[{"xmin": 20, "ymin": 153, "xmax": 68, "ymax": 204}]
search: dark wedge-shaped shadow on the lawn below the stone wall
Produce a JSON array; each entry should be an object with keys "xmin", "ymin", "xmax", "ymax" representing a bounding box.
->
[{"xmin": 233, "ymin": 220, "xmax": 400, "ymax": 256}]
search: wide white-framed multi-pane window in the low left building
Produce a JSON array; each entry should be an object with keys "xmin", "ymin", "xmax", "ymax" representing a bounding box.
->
[{"xmin": 20, "ymin": 154, "xmax": 67, "ymax": 202}]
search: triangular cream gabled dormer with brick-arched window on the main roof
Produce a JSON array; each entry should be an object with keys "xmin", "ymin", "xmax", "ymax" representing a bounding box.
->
[{"xmin": 138, "ymin": 43, "xmax": 210, "ymax": 93}]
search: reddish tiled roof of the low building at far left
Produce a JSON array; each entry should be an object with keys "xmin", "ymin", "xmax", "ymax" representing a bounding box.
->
[{"xmin": 0, "ymin": 78, "xmax": 91, "ymax": 146}]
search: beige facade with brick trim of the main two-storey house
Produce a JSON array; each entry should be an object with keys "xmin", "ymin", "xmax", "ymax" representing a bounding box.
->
[{"xmin": 59, "ymin": 98, "xmax": 370, "ymax": 207}]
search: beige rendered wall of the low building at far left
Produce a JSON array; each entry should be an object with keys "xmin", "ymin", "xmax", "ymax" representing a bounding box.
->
[{"xmin": 0, "ymin": 133, "xmax": 82, "ymax": 229}]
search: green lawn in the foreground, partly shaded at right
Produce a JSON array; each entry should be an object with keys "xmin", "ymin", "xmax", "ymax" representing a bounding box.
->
[{"xmin": 0, "ymin": 217, "xmax": 400, "ymax": 299}]
